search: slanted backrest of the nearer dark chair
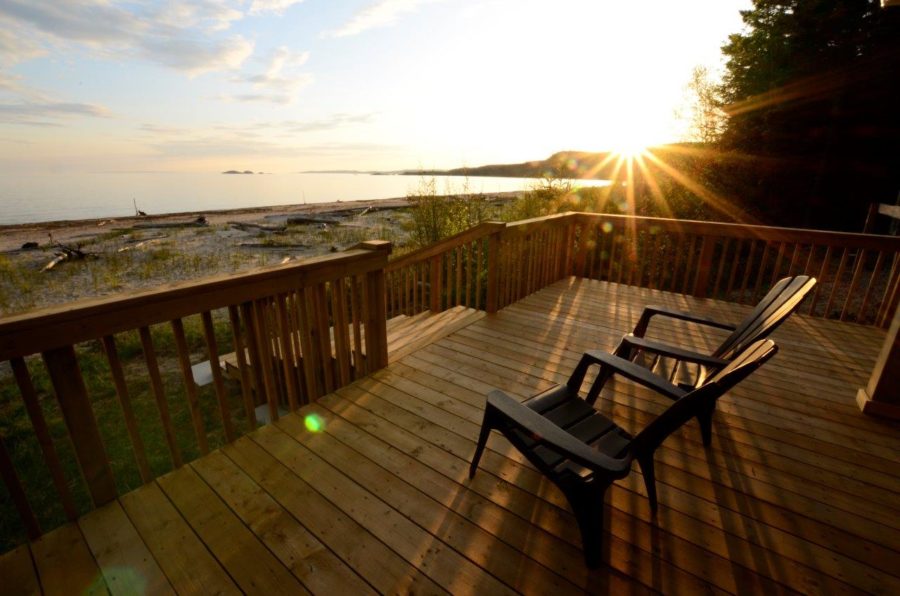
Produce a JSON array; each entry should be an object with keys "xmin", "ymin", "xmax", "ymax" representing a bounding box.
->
[{"xmin": 632, "ymin": 339, "xmax": 778, "ymax": 453}]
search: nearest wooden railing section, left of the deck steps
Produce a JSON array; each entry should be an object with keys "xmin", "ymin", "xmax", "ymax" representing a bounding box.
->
[{"xmin": 0, "ymin": 242, "xmax": 390, "ymax": 538}]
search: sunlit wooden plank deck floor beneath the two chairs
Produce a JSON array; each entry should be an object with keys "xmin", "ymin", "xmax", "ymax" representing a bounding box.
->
[{"xmin": 0, "ymin": 278, "xmax": 900, "ymax": 594}]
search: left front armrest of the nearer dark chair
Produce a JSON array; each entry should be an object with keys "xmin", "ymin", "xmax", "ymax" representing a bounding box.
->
[{"xmin": 488, "ymin": 389, "xmax": 631, "ymax": 474}]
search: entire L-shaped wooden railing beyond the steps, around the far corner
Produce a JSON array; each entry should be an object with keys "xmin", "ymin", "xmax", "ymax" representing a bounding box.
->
[{"xmin": 386, "ymin": 213, "xmax": 900, "ymax": 327}]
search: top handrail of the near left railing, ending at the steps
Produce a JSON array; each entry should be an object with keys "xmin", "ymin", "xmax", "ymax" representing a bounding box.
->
[{"xmin": 0, "ymin": 241, "xmax": 390, "ymax": 361}]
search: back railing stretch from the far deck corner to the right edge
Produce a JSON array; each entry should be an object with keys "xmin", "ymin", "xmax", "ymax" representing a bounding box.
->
[{"xmin": 572, "ymin": 214, "xmax": 900, "ymax": 327}]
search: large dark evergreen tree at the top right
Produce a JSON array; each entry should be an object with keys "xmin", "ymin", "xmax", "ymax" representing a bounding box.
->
[{"xmin": 719, "ymin": 0, "xmax": 900, "ymax": 230}]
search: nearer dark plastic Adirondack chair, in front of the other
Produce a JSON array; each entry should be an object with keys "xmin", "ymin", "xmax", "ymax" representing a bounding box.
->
[{"xmin": 469, "ymin": 340, "xmax": 778, "ymax": 567}]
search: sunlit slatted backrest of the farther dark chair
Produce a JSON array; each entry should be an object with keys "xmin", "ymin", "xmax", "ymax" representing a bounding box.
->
[{"xmin": 712, "ymin": 275, "xmax": 816, "ymax": 360}]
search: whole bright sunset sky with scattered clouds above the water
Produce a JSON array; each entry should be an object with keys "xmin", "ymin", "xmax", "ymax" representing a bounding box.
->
[{"xmin": 0, "ymin": 0, "xmax": 750, "ymax": 173}]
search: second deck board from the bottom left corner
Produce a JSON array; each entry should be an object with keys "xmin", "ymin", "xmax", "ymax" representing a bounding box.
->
[{"xmin": 31, "ymin": 523, "xmax": 109, "ymax": 594}]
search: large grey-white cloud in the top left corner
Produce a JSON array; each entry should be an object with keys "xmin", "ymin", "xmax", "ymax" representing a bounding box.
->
[{"xmin": 0, "ymin": 0, "xmax": 253, "ymax": 76}]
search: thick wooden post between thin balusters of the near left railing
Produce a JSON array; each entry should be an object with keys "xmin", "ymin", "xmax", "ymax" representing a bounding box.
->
[{"xmin": 42, "ymin": 346, "xmax": 117, "ymax": 507}]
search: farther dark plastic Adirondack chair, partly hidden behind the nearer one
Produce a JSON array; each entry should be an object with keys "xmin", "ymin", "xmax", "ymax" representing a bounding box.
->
[{"xmin": 587, "ymin": 275, "xmax": 816, "ymax": 445}]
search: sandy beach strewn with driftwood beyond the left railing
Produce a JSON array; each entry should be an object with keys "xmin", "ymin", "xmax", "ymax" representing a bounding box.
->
[{"xmin": 0, "ymin": 193, "xmax": 518, "ymax": 317}]
